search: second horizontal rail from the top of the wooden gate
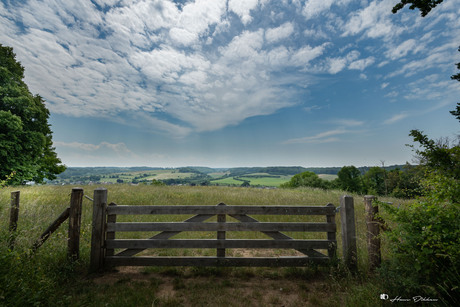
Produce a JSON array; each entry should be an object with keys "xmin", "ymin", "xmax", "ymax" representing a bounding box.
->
[{"xmin": 107, "ymin": 222, "xmax": 336, "ymax": 232}]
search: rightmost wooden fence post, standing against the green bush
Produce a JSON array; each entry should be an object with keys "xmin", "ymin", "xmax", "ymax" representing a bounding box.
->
[{"xmin": 364, "ymin": 195, "xmax": 382, "ymax": 272}]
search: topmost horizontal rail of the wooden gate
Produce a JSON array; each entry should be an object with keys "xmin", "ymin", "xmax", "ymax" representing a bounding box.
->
[{"xmin": 107, "ymin": 206, "xmax": 334, "ymax": 215}]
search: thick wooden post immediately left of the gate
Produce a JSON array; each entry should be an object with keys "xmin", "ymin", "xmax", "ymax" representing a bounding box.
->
[{"xmin": 89, "ymin": 188, "xmax": 107, "ymax": 272}]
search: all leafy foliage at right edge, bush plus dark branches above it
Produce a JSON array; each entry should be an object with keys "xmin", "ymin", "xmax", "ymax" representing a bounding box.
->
[{"xmin": 381, "ymin": 101, "xmax": 460, "ymax": 306}]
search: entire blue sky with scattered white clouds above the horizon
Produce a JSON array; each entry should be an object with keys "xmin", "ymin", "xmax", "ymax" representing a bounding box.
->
[{"xmin": 0, "ymin": 0, "xmax": 460, "ymax": 167}]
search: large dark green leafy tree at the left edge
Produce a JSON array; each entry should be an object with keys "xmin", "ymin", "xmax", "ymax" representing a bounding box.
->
[{"xmin": 0, "ymin": 44, "xmax": 66, "ymax": 184}]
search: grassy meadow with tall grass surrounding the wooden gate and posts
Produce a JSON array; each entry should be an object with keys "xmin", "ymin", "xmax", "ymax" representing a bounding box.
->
[{"xmin": 0, "ymin": 185, "xmax": 410, "ymax": 306}]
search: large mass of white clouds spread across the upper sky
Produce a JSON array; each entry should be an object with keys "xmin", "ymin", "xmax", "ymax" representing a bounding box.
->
[{"xmin": 0, "ymin": 0, "xmax": 458, "ymax": 146}]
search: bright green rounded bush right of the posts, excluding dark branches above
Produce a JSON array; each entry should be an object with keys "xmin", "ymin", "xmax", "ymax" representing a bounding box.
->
[{"xmin": 380, "ymin": 173, "xmax": 460, "ymax": 305}]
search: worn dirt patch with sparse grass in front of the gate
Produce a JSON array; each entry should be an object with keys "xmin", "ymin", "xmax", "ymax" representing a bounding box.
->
[{"xmin": 93, "ymin": 267, "xmax": 343, "ymax": 306}]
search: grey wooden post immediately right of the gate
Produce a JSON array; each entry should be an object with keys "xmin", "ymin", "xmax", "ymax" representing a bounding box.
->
[{"xmin": 340, "ymin": 195, "xmax": 357, "ymax": 271}]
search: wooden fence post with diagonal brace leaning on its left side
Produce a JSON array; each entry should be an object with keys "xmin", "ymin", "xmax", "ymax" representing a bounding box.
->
[{"xmin": 67, "ymin": 188, "xmax": 83, "ymax": 260}]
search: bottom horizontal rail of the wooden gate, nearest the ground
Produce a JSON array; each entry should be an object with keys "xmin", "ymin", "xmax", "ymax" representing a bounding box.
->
[{"xmin": 106, "ymin": 256, "xmax": 330, "ymax": 267}]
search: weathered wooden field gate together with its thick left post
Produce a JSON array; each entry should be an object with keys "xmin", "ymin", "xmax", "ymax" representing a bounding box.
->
[{"xmin": 90, "ymin": 189, "xmax": 337, "ymax": 271}]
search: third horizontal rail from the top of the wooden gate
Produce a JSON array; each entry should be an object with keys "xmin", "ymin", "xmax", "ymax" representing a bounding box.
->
[{"xmin": 106, "ymin": 239, "xmax": 334, "ymax": 249}]
